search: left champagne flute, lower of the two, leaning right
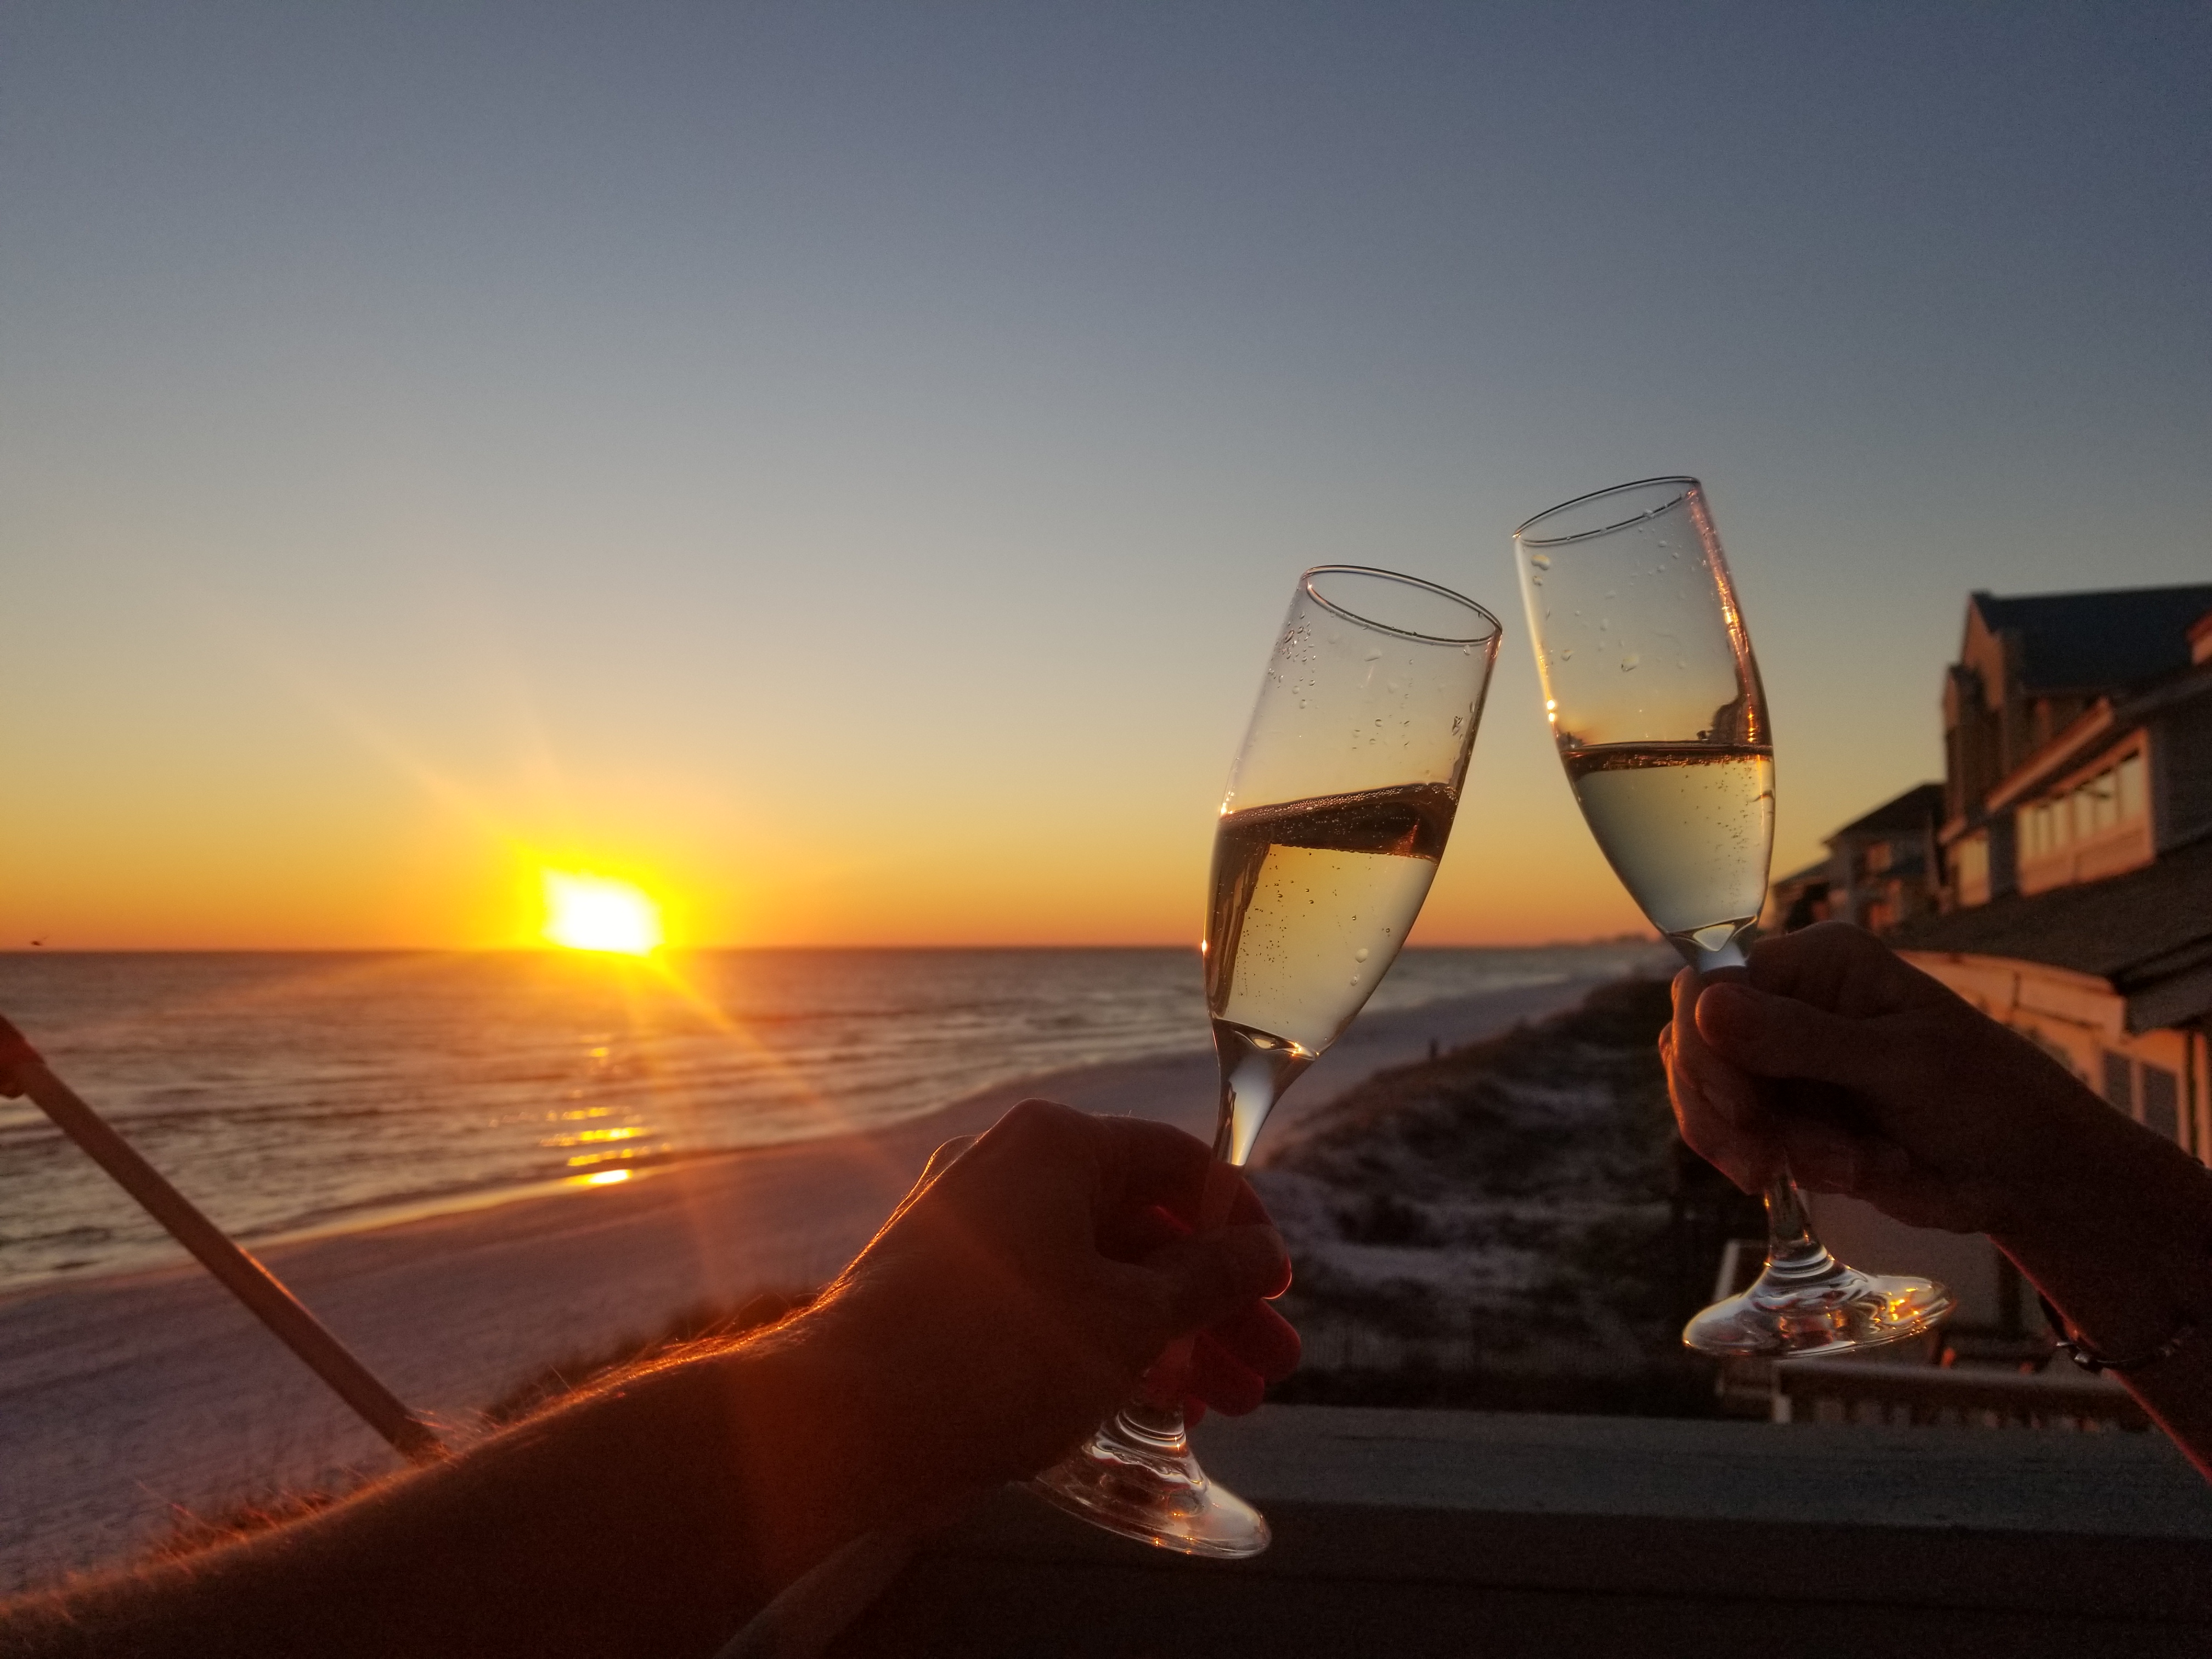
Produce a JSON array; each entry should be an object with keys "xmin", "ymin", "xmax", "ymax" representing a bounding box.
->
[{"xmin": 1035, "ymin": 564, "xmax": 1498, "ymax": 1558}]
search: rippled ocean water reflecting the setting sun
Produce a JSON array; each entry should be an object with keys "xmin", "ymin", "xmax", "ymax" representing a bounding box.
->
[{"xmin": 0, "ymin": 943, "xmax": 1655, "ymax": 1292}]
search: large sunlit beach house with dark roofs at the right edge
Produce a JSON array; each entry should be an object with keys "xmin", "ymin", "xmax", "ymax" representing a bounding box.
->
[{"xmin": 1882, "ymin": 584, "xmax": 2212, "ymax": 1157}]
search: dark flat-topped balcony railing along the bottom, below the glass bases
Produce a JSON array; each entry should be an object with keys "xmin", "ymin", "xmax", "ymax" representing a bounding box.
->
[{"xmin": 830, "ymin": 1407, "xmax": 2212, "ymax": 1659}]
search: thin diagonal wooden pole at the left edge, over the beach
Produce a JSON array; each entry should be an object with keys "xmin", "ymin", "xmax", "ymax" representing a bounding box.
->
[{"xmin": 0, "ymin": 1018, "xmax": 444, "ymax": 1462}]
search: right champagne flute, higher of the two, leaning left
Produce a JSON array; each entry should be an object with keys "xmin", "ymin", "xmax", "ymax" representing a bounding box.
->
[{"xmin": 1513, "ymin": 478, "xmax": 1951, "ymax": 1356}]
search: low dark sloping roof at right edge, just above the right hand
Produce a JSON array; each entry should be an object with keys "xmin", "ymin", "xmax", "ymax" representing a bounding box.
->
[{"xmin": 1889, "ymin": 836, "xmax": 2212, "ymax": 1022}]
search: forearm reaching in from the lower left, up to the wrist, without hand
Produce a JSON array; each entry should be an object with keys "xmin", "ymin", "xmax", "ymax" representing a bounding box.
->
[{"xmin": 0, "ymin": 1329, "xmax": 922, "ymax": 1659}]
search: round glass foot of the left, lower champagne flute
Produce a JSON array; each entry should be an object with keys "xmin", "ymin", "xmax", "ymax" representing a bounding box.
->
[{"xmin": 1029, "ymin": 1404, "xmax": 1272, "ymax": 1562}]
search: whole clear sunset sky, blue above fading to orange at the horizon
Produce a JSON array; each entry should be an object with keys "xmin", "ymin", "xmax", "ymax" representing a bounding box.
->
[{"xmin": 0, "ymin": 0, "xmax": 2212, "ymax": 949}]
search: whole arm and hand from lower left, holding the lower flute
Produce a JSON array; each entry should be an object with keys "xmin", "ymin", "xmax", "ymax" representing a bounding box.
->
[{"xmin": 0, "ymin": 1102, "xmax": 1299, "ymax": 1659}]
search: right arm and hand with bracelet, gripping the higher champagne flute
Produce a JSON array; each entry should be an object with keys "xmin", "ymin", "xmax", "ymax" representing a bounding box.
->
[{"xmin": 1659, "ymin": 922, "xmax": 2212, "ymax": 1475}]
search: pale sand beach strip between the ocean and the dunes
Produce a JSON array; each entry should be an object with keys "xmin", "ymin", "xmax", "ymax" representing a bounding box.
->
[{"xmin": 0, "ymin": 980, "xmax": 1628, "ymax": 1593}]
